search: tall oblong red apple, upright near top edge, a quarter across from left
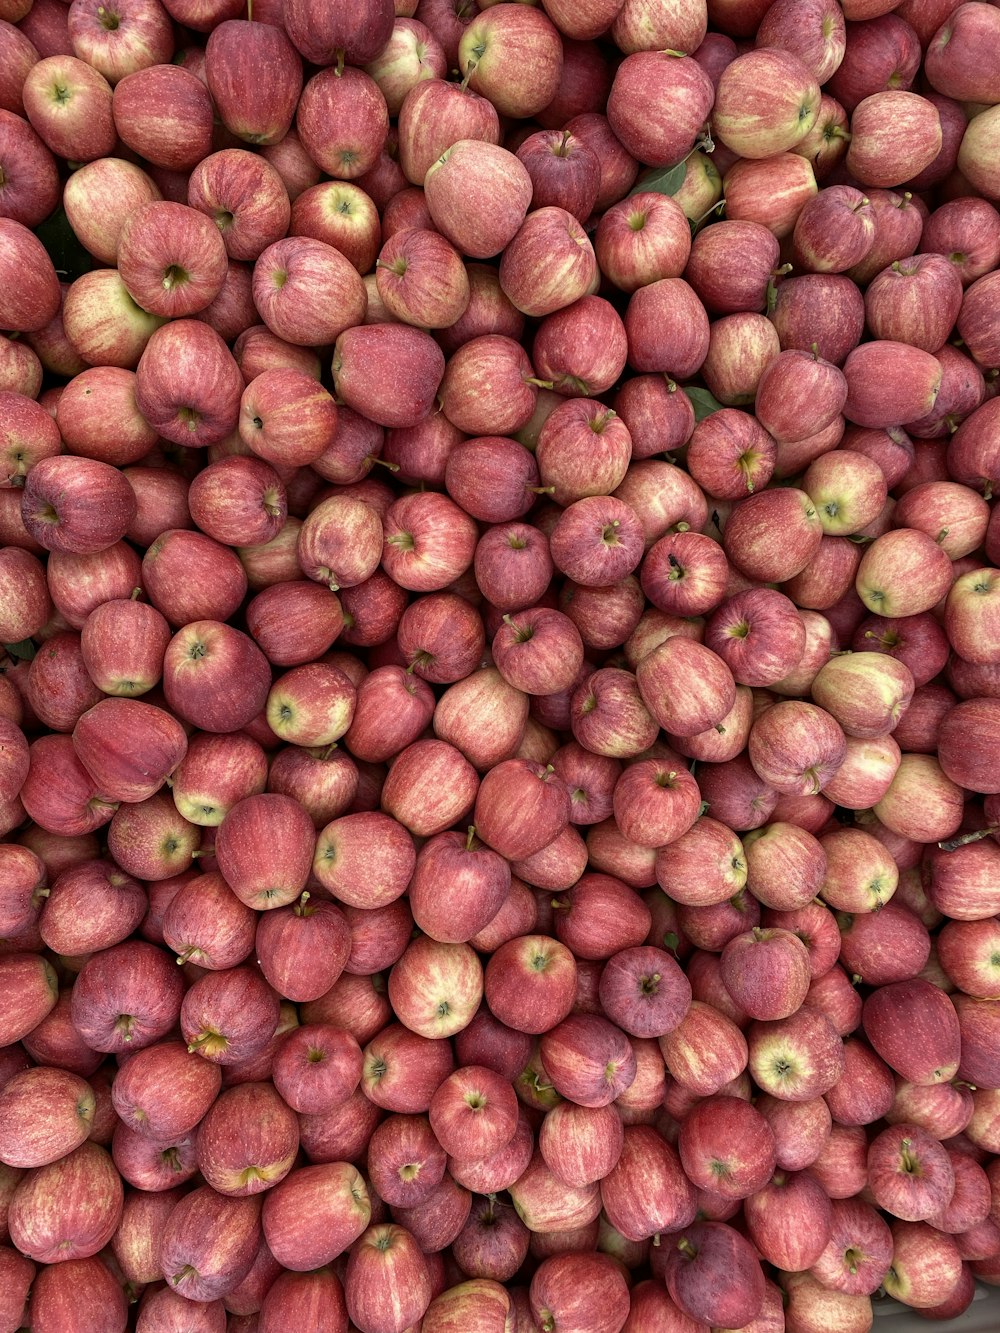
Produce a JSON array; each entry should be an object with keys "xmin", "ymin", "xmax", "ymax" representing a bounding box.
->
[{"xmin": 205, "ymin": 16, "xmax": 303, "ymax": 145}]
